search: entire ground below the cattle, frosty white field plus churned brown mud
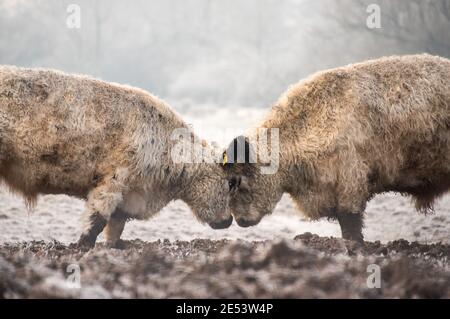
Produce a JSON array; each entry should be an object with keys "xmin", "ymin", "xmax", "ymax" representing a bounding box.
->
[{"xmin": 0, "ymin": 189, "xmax": 450, "ymax": 298}]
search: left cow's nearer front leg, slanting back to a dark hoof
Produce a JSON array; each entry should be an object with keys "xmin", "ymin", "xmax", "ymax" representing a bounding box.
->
[{"xmin": 78, "ymin": 182, "xmax": 122, "ymax": 250}]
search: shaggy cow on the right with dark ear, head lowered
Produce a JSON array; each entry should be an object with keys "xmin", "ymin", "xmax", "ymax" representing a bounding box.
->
[{"xmin": 224, "ymin": 55, "xmax": 450, "ymax": 243}]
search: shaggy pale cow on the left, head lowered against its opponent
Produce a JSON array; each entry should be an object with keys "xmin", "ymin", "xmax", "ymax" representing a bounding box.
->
[{"xmin": 0, "ymin": 66, "xmax": 232, "ymax": 248}]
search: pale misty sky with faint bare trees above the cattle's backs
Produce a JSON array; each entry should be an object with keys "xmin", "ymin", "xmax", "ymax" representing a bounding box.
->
[{"xmin": 0, "ymin": 0, "xmax": 450, "ymax": 108}]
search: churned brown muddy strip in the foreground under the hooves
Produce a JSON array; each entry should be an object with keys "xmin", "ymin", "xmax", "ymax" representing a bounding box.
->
[{"xmin": 0, "ymin": 233, "xmax": 450, "ymax": 298}]
